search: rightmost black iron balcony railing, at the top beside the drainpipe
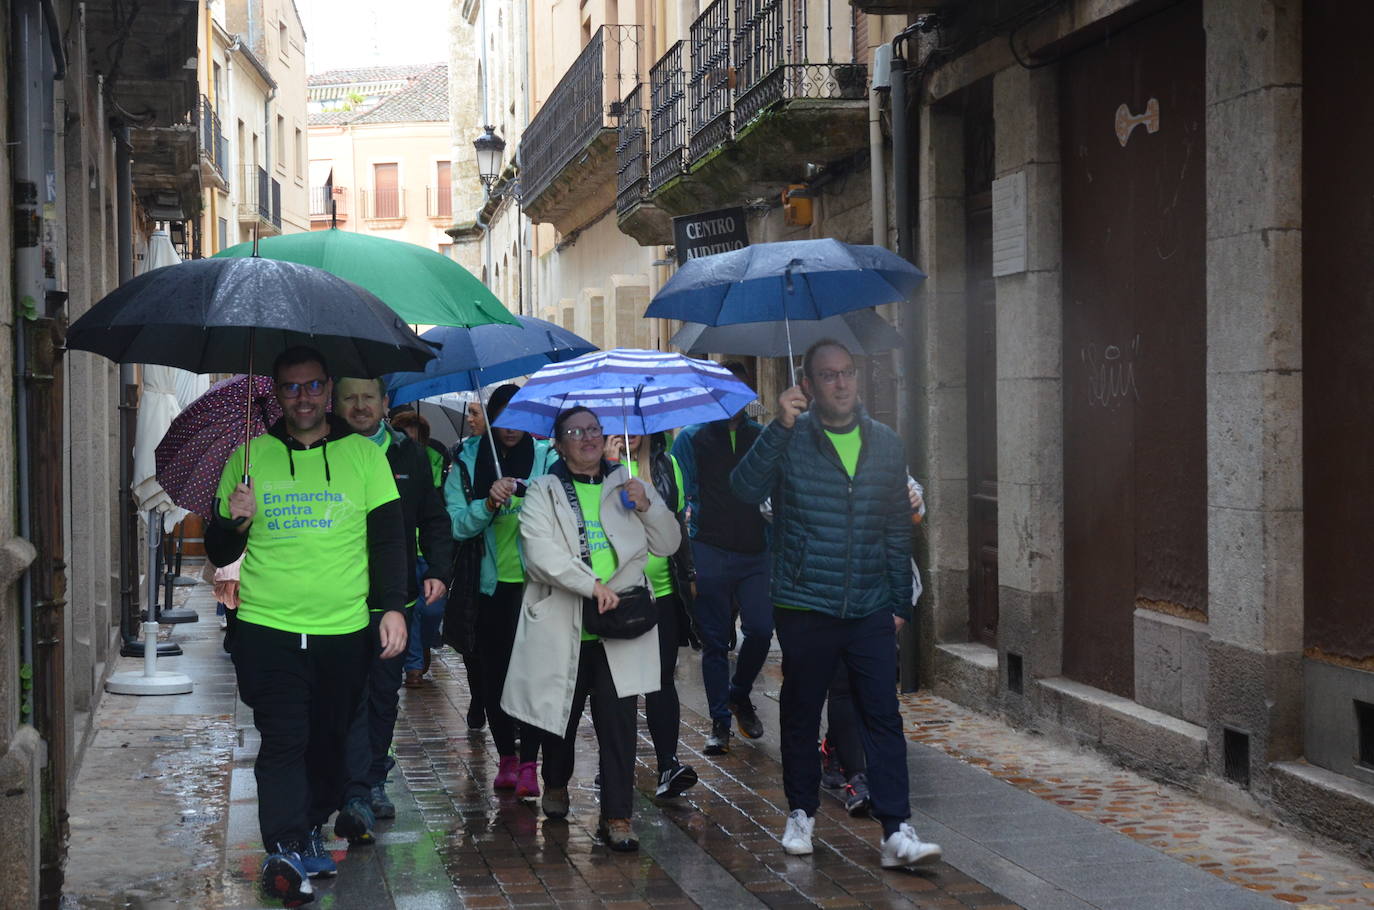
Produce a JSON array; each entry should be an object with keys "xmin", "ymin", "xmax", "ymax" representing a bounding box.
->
[{"xmin": 734, "ymin": 0, "xmax": 867, "ymax": 131}]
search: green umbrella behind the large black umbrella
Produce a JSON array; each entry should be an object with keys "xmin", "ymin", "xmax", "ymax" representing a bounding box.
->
[{"xmin": 214, "ymin": 228, "xmax": 518, "ymax": 327}]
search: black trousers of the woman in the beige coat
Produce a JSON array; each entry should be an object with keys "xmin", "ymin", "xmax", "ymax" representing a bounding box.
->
[{"xmin": 544, "ymin": 642, "xmax": 638, "ymax": 818}]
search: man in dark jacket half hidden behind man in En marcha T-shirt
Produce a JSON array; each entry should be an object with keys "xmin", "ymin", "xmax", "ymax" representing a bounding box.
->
[{"xmin": 334, "ymin": 378, "xmax": 453, "ymax": 844}]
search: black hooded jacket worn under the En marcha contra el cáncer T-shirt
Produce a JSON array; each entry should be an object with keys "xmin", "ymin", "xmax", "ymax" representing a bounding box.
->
[{"xmin": 205, "ymin": 414, "xmax": 406, "ymax": 612}]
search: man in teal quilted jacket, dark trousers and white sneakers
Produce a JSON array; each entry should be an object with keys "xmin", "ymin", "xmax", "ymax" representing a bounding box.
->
[{"xmin": 731, "ymin": 340, "xmax": 940, "ymax": 869}]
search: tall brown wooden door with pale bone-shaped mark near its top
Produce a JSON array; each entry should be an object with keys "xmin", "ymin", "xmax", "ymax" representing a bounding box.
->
[{"xmin": 1061, "ymin": 0, "xmax": 1206, "ymax": 697}]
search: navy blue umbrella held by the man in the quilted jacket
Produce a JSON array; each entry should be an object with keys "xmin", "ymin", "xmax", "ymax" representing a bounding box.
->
[{"xmin": 644, "ymin": 238, "xmax": 926, "ymax": 376}]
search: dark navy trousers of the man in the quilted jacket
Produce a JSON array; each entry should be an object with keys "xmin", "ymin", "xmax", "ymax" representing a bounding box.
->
[{"xmin": 774, "ymin": 609, "xmax": 911, "ymax": 822}]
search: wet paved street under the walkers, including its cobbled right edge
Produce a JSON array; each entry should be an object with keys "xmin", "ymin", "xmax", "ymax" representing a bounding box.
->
[{"xmin": 65, "ymin": 586, "xmax": 1374, "ymax": 910}]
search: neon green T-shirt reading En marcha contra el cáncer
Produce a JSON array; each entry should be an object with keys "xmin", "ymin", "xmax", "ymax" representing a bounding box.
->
[{"xmin": 218, "ymin": 434, "xmax": 398, "ymax": 635}]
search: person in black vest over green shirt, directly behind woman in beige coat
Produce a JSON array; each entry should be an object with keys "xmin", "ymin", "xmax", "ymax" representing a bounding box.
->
[{"xmin": 606, "ymin": 433, "xmax": 697, "ymax": 799}]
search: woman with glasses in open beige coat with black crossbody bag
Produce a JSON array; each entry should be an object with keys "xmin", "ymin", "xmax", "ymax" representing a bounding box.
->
[{"xmin": 502, "ymin": 407, "xmax": 682, "ymax": 852}]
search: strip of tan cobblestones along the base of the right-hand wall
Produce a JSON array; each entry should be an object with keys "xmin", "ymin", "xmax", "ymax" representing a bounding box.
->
[{"xmin": 903, "ymin": 694, "xmax": 1374, "ymax": 910}]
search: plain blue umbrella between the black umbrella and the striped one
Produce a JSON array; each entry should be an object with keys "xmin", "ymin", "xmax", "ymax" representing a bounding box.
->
[{"xmin": 386, "ymin": 316, "xmax": 596, "ymax": 404}]
